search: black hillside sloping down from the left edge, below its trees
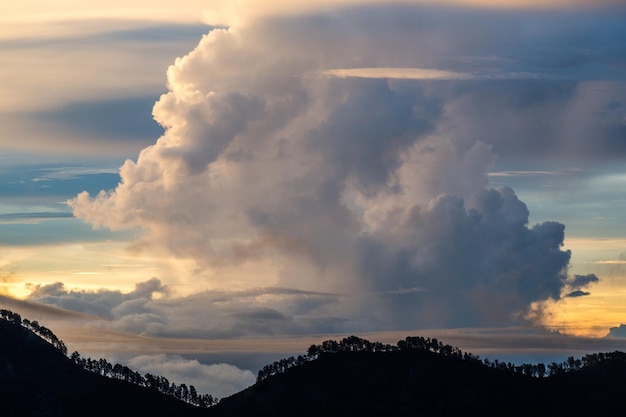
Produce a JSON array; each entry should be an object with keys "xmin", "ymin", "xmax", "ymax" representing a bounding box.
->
[{"xmin": 0, "ymin": 320, "xmax": 207, "ymax": 417}]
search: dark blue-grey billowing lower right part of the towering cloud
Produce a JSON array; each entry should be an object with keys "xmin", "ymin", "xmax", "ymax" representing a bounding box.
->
[{"xmin": 354, "ymin": 188, "xmax": 582, "ymax": 327}]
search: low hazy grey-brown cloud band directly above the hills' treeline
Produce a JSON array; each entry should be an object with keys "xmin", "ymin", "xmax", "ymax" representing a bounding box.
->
[{"xmin": 8, "ymin": 282, "xmax": 624, "ymax": 370}]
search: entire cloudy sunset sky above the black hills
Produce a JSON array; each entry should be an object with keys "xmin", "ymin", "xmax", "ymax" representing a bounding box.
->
[{"xmin": 0, "ymin": 0, "xmax": 626, "ymax": 397}]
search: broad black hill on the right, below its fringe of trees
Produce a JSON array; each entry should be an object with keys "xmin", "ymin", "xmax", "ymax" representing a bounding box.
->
[{"xmin": 209, "ymin": 350, "xmax": 626, "ymax": 417}]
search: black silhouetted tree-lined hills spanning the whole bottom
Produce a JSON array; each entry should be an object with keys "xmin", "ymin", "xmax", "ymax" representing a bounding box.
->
[{"xmin": 0, "ymin": 312, "xmax": 626, "ymax": 417}]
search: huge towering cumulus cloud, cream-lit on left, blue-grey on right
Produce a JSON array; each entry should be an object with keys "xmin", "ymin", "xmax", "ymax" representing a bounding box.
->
[{"xmin": 70, "ymin": 6, "xmax": 608, "ymax": 328}]
